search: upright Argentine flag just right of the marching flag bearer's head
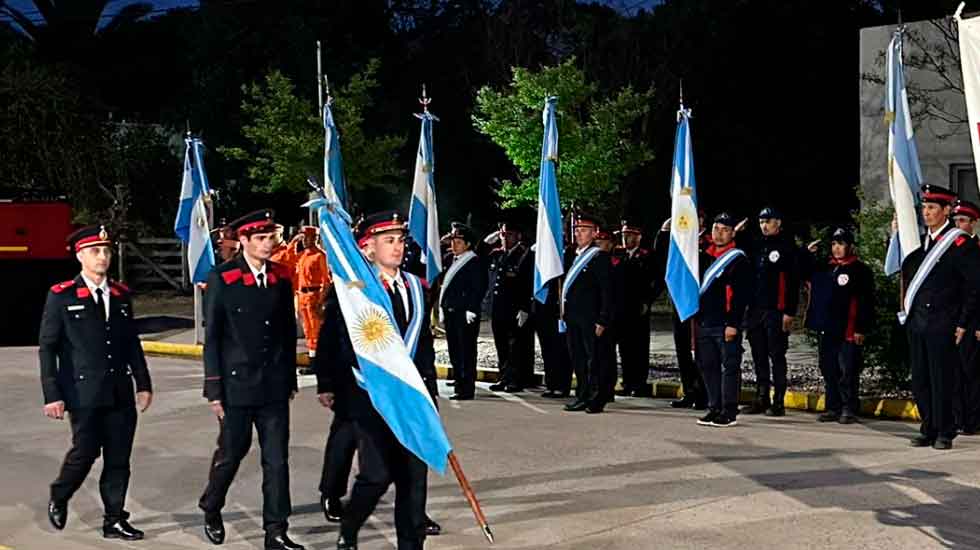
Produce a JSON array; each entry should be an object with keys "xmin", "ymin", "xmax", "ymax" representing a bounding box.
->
[{"xmin": 408, "ymin": 110, "xmax": 442, "ymax": 284}]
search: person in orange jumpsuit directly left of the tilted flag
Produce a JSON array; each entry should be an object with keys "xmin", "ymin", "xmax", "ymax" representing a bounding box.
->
[{"xmin": 290, "ymin": 227, "xmax": 330, "ymax": 357}]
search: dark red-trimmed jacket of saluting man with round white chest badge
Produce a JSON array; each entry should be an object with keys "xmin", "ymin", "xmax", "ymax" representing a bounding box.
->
[{"xmin": 801, "ymin": 254, "xmax": 875, "ymax": 342}]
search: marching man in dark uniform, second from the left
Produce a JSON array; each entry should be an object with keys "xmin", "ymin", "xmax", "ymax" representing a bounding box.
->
[{"xmin": 198, "ymin": 210, "xmax": 303, "ymax": 550}]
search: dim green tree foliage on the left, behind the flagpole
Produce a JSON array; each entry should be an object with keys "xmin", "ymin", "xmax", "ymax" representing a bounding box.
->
[{"xmin": 219, "ymin": 60, "xmax": 406, "ymax": 196}]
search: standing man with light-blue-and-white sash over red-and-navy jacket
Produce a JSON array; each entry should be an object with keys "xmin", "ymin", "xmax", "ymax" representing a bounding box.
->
[{"xmin": 694, "ymin": 213, "xmax": 752, "ymax": 428}]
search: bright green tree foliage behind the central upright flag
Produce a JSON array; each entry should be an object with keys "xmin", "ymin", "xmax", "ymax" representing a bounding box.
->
[{"xmin": 473, "ymin": 58, "xmax": 653, "ymax": 207}]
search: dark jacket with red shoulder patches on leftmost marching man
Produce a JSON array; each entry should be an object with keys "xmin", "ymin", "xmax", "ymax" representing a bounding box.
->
[{"xmin": 39, "ymin": 275, "xmax": 153, "ymax": 411}]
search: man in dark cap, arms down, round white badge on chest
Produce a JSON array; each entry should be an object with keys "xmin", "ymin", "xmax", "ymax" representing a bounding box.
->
[{"xmin": 742, "ymin": 208, "xmax": 800, "ymax": 416}]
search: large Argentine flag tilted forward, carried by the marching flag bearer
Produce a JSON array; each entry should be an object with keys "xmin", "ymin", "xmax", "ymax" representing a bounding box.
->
[{"xmin": 308, "ymin": 200, "xmax": 452, "ymax": 474}]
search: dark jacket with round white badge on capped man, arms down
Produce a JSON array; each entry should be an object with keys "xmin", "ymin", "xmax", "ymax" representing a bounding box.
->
[{"xmin": 749, "ymin": 233, "xmax": 800, "ymax": 316}]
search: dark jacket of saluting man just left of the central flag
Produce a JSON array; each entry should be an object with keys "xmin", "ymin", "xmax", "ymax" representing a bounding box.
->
[{"xmin": 488, "ymin": 243, "xmax": 534, "ymax": 319}]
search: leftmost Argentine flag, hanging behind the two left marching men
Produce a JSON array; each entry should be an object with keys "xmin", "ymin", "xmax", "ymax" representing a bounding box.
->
[{"xmin": 174, "ymin": 138, "xmax": 214, "ymax": 283}]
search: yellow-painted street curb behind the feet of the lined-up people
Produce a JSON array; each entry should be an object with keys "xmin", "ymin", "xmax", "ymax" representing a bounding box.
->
[{"xmin": 142, "ymin": 340, "xmax": 921, "ymax": 422}]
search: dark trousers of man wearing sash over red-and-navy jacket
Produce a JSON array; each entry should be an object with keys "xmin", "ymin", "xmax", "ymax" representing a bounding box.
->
[{"xmin": 697, "ymin": 327, "xmax": 745, "ymax": 418}]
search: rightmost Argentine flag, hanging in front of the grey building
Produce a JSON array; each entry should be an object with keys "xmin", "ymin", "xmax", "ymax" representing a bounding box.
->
[{"xmin": 884, "ymin": 29, "xmax": 922, "ymax": 275}]
